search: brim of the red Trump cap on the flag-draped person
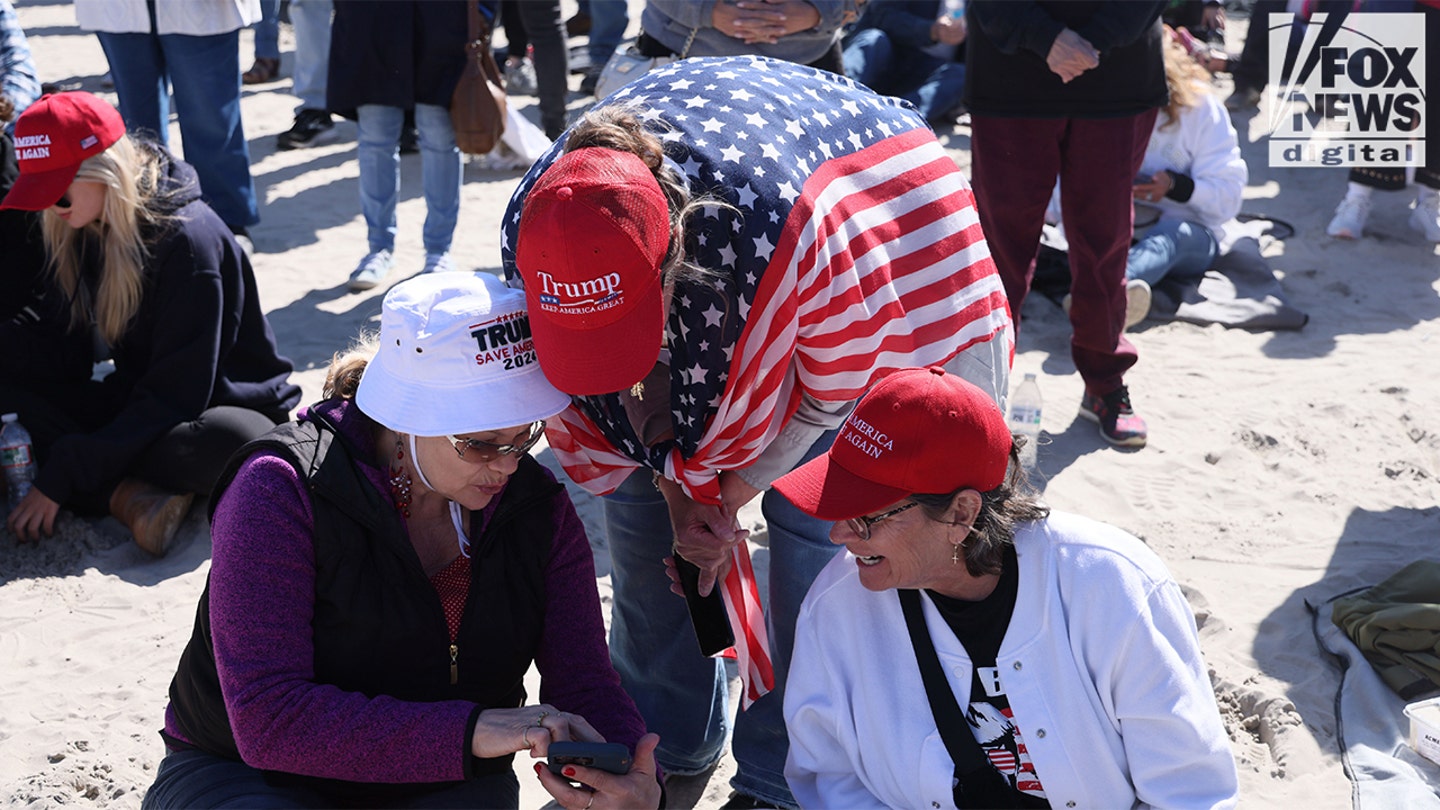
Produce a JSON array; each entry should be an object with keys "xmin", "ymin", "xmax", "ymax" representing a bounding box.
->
[{"xmin": 526, "ymin": 274, "xmax": 665, "ymax": 396}]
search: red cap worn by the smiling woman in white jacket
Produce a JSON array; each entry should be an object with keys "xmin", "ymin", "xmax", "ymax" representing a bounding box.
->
[{"xmin": 775, "ymin": 366, "xmax": 1012, "ymax": 520}]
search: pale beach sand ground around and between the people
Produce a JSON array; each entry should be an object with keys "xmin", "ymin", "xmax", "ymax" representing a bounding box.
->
[{"xmin": 0, "ymin": 0, "xmax": 1440, "ymax": 810}]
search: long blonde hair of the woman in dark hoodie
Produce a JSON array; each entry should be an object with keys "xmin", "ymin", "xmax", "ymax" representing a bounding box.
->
[{"xmin": 40, "ymin": 135, "xmax": 171, "ymax": 343}]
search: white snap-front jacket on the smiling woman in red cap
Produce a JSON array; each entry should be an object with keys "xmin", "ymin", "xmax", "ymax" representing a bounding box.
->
[{"xmin": 785, "ymin": 513, "xmax": 1237, "ymax": 810}]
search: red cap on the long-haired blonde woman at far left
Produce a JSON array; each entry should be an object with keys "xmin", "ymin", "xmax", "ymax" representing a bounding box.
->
[{"xmin": 0, "ymin": 91, "xmax": 125, "ymax": 210}]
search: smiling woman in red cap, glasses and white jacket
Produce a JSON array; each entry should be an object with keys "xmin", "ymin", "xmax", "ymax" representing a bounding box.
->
[{"xmin": 775, "ymin": 368, "xmax": 1237, "ymax": 807}]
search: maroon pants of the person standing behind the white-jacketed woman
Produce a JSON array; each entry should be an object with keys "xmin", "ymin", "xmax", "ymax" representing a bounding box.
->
[{"xmin": 971, "ymin": 110, "xmax": 1156, "ymax": 396}]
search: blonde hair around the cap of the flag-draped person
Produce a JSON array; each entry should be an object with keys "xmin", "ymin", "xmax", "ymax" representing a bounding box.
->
[{"xmin": 564, "ymin": 102, "xmax": 734, "ymax": 288}]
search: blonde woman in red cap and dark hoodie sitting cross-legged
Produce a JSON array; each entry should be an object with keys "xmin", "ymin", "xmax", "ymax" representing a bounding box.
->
[{"xmin": 0, "ymin": 92, "xmax": 300, "ymax": 555}]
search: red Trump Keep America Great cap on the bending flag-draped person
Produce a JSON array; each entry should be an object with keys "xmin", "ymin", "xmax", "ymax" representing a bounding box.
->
[{"xmin": 516, "ymin": 147, "xmax": 670, "ymax": 396}]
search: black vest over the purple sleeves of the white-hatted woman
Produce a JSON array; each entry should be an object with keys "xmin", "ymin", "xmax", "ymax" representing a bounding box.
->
[{"xmin": 162, "ymin": 409, "xmax": 562, "ymax": 803}]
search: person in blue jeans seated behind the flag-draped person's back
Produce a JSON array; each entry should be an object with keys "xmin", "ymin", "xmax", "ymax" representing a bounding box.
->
[{"xmin": 844, "ymin": 0, "xmax": 966, "ymax": 124}]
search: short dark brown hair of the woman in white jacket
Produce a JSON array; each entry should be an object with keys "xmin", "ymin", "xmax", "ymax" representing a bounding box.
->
[{"xmin": 910, "ymin": 435, "xmax": 1050, "ymax": 577}]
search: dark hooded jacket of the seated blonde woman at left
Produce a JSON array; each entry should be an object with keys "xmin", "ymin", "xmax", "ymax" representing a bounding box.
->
[{"xmin": 35, "ymin": 146, "xmax": 300, "ymax": 503}]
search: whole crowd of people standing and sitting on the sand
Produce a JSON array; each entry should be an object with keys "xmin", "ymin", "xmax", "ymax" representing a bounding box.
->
[{"xmin": 0, "ymin": 0, "xmax": 1440, "ymax": 810}]
